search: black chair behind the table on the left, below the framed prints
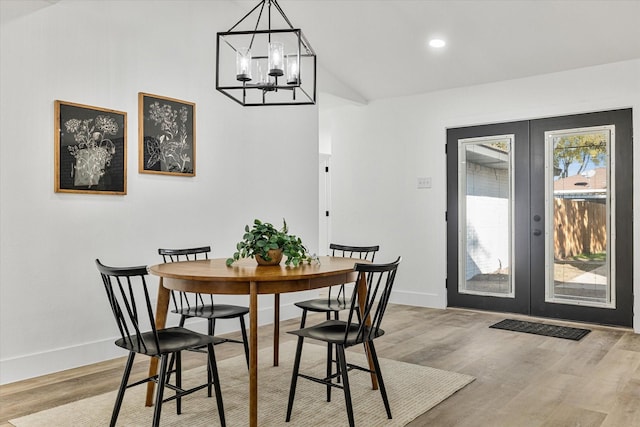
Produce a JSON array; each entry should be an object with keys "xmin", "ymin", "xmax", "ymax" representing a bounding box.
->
[{"xmin": 158, "ymin": 246, "xmax": 249, "ymax": 396}]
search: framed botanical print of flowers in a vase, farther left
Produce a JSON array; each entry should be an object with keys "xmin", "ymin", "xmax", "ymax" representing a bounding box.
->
[{"xmin": 54, "ymin": 100, "xmax": 127, "ymax": 195}]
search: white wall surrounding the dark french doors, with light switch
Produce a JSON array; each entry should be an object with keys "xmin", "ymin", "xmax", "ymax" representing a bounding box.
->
[{"xmin": 321, "ymin": 60, "xmax": 640, "ymax": 332}]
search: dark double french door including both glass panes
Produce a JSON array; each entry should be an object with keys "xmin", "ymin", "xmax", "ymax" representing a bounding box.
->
[{"xmin": 447, "ymin": 109, "xmax": 633, "ymax": 326}]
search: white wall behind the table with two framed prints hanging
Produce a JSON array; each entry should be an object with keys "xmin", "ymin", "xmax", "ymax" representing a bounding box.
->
[{"xmin": 0, "ymin": 0, "xmax": 318, "ymax": 383}]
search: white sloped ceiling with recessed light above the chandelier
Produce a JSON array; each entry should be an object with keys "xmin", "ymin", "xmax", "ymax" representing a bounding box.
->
[{"xmin": 5, "ymin": 0, "xmax": 640, "ymax": 103}]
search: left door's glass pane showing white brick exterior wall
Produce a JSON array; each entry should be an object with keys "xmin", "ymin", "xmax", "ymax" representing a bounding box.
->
[{"xmin": 458, "ymin": 135, "xmax": 514, "ymax": 297}]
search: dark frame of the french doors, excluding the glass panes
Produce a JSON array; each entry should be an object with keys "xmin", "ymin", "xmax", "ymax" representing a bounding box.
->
[{"xmin": 447, "ymin": 109, "xmax": 633, "ymax": 326}]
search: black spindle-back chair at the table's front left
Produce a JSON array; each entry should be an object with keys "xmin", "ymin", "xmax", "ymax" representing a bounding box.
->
[{"xmin": 96, "ymin": 259, "xmax": 226, "ymax": 427}]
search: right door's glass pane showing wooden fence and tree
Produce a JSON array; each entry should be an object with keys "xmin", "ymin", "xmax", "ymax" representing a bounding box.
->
[{"xmin": 545, "ymin": 126, "xmax": 615, "ymax": 307}]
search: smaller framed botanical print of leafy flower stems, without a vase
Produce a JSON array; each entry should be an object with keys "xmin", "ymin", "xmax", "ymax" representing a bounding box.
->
[{"xmin": 138, "ymin": 92, "xmax": 196, "ymax": 176}]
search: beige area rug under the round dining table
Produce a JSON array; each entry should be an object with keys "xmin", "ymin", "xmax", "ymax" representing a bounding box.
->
[{"xmin": 10, "ymin": 342, "xmax": 474, "ymax": 427}]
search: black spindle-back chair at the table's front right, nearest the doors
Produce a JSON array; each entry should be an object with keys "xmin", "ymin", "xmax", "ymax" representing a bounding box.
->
[{"xmin": 286, "ymin": 257, "xmax": 401, "ymax": 427}]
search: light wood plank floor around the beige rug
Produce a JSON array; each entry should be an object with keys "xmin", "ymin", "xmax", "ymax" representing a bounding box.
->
[{"xmin": 0, "ymin": 305, "xmax": 640, "ymax": 427}]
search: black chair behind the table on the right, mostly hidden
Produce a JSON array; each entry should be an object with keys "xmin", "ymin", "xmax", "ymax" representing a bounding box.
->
[{"xmin": 295, "ymin": 243, "xmax": 380, "ymax": 402}]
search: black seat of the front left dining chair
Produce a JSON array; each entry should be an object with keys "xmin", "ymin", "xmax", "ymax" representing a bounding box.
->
[{"xmin": 115, "ymin": 327, "xmax": 224, "ymax": 356}]
